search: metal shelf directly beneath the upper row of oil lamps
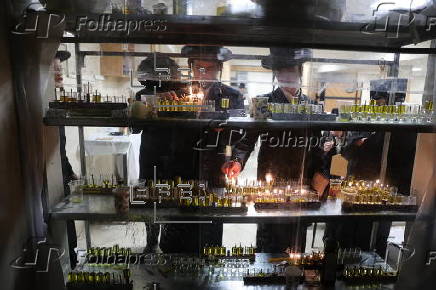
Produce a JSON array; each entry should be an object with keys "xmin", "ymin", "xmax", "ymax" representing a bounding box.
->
[{"xmin": 44, "ymin": 117, "xmax": 436, "ymax": 133}]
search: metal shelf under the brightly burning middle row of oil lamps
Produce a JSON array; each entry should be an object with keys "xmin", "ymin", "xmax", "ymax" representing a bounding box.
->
[{"xmin": 50, "ymin": 195, "xmax": 416, "ymax": 223}]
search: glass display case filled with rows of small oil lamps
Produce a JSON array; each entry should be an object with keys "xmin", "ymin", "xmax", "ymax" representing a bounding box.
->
[{"xmin": 28, "ymin": 0, "xmax": 436, "ymax": 289}]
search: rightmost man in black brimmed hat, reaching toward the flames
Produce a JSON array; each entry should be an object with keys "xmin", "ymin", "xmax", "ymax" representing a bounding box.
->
[{"xmin": 221, "ymin": 48, "xmax": 320, "ymax": 253}]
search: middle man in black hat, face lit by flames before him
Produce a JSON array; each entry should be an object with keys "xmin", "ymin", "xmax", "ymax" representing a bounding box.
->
[{"xmin": 160, "ymin": 46, "xmax": 244, "ymax": 253}]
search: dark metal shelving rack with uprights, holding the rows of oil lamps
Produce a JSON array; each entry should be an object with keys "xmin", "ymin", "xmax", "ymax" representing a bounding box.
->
[{"xmin": 44, "ymin": 8, "xmax": 436, "ymax": 254}]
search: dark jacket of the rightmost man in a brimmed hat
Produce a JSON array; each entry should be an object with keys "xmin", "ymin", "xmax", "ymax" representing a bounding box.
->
[{"xmin": 233, "ymin": 89, "xmax": 321, "ymax": 180}]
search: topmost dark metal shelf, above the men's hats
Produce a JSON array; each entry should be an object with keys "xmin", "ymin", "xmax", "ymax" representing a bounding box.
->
[{"xmin": 62, "ymin": 14, "xmax": 436, "ymax": 53}]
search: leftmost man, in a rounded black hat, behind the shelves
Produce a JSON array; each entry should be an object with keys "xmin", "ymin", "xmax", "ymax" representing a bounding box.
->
[{"xmin": 133, "ymin": 53, "xmax": 190, "ymax": 253}]
